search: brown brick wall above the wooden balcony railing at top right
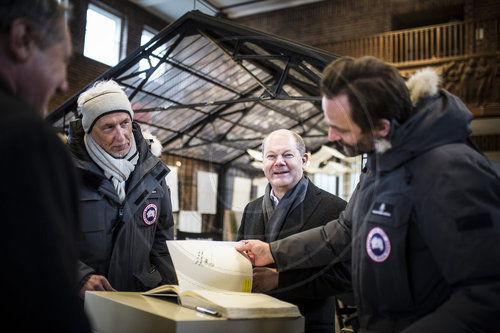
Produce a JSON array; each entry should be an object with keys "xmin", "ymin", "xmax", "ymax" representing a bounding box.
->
[{"xmin": 236, "ymin": 0, "xmax": 500, "ymax": 50}]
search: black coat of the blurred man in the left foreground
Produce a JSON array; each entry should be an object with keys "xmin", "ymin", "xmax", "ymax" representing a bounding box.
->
[{"xmin": 0, "ymin": 113, "xmax": 90, "ymax": 332}]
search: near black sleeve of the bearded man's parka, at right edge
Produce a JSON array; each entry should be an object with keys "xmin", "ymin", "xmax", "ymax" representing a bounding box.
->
[{"xmin": 404, "ymin": 147, "xmax": 500, "ymax": 333}]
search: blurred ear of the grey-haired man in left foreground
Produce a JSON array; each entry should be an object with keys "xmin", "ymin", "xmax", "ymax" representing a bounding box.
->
[{"xmin": 8, "ymin": 18, "xmax": 35, "ymax": 62}]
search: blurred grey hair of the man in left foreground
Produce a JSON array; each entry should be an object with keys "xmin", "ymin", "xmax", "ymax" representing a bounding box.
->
[{"xmin": 0, "ymin": 0, "xmax": 69, "ymax": 49}]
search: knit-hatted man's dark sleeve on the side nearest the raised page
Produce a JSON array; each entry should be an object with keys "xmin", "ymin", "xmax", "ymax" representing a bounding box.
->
[{"xmin": 151, "ymin": 180, "xmax": 177, "ymax": 284}]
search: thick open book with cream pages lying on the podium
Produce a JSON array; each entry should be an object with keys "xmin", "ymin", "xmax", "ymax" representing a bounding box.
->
[{"xmin": 143, "ymin": 240, "xmax": 300, "ymax": 319}]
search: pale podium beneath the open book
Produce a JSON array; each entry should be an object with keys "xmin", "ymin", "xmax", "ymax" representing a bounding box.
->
[{"xmin": 85, "ymin": 291, "xmax": 304, "ymax": 333}]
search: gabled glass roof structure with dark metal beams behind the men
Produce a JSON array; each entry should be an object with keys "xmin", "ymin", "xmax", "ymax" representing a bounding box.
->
[{"xmin": 47, "ymin": 11, "xmax": 337, "ymax": 168}]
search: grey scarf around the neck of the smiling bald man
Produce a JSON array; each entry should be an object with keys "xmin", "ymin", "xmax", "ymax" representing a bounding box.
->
[{"xmin": 262, "ymin": 177, "xmax": 309, "ymax": 242}]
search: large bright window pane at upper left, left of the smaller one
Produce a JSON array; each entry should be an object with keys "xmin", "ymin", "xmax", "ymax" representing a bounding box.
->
[{"xmin": 83, "ymin": 4, "xmax": 122, "ymax": 66}]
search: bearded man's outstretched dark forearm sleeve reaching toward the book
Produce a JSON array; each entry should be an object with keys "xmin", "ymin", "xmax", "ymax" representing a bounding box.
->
[{"xmin": 270, "ymin": 185, "xmax": 357, "ymax": 272}]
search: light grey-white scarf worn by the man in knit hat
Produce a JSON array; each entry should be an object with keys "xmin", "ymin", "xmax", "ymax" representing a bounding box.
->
[{"xmin": 83, "ymin": 133, "xmax": 139, "ymax": 202}]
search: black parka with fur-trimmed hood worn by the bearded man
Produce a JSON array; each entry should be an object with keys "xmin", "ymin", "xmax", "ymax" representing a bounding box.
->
[{"xmin": 271, "ymin": 69, "xmax": 500, "ymax": 333}]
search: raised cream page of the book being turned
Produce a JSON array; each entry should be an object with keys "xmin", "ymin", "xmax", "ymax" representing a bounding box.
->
[{"xmin": 167, "ymin": 240, "xmax": 252, "ymax": 292}]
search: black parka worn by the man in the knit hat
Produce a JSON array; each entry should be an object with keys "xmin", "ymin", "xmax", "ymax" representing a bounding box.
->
[{"xmin": 69, "ymin": 120, "xmax": 175, "ymax": 291}]
